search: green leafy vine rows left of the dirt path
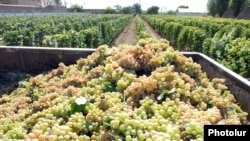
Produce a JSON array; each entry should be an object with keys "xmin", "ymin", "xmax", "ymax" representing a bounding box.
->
[{"xmin": 0, "ymin": 14, "xmax": 132, "ymax": 48}]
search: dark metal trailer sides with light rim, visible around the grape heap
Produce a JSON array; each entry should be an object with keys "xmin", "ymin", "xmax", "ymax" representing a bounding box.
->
[{"xmin": 0, "ymin": 46, "xmax": 250, "ymax": 121}]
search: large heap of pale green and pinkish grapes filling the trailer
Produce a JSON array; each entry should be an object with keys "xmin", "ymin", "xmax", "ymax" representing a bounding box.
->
[{"xmin": 0, "ymin": 38, "xmax": 247, "ymax": 141}]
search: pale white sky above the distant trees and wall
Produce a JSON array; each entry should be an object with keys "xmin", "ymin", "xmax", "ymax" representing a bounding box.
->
[{"xmin": 62, "ymin": 0, "xmax": 208, "ymax": 12}]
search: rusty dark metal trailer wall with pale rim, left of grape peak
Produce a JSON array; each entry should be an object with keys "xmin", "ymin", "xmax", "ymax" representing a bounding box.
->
[{"xmin": 0, "ymin": 46, "xmax": 95, "ymax": 73}]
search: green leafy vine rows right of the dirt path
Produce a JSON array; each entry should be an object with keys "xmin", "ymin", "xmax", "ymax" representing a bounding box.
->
[{"xmin": 142, "ymin": 15, "xmax": 250, "ymax": 78}]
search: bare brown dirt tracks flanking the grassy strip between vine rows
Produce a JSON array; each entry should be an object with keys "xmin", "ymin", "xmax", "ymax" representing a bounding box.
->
[{"xmin": 114, "ymin": 18, "xmax": 161, "ymax": 46}]
